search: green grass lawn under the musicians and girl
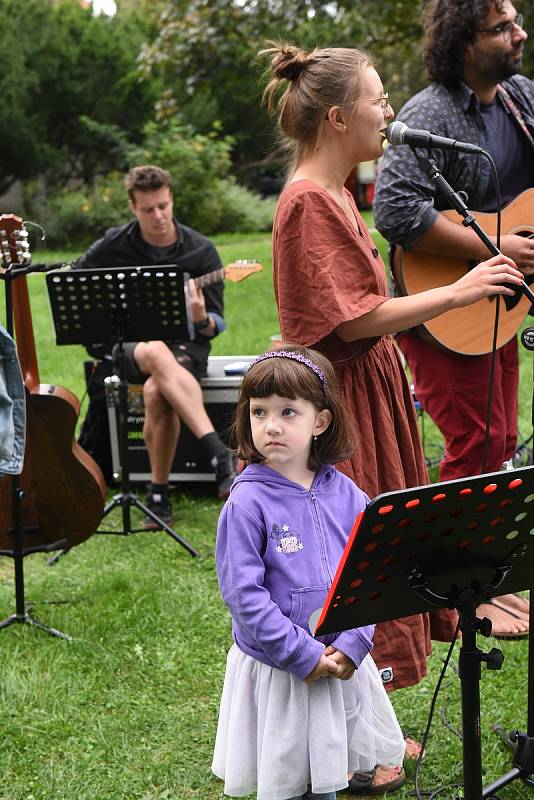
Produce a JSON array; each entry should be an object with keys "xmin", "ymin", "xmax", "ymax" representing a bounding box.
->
[{"xmin": 0, "ymin": 227, "xmax": 531, "ymax": 800}]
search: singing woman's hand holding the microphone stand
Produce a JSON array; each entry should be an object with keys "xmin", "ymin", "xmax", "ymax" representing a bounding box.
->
[{"xmin": 451, "ymin": 255, "xmax": 523, "ymax": 308}]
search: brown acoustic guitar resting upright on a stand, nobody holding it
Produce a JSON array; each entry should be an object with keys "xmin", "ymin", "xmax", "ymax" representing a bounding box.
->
[{"xmin": 0, "ymin": 214, "xmax": 105, "ymax": 552}]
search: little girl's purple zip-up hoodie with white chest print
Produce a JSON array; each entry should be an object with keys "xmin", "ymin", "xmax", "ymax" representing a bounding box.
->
[{"xmin": 216, "ymin": 464, "xmax": 374, "ymax": 679}]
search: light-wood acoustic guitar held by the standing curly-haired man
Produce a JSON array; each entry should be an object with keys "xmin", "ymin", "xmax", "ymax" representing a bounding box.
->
[{"xmin": 393, "ymin": 189, "xmax": 534, "ymax": 356}]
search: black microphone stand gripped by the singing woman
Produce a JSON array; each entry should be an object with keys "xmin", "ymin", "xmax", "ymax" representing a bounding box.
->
[{"xmin": 412, "ymin": 147, "xmax": 534, "ymax": 799}]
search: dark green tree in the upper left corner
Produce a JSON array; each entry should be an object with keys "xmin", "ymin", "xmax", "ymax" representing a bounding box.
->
[{"xmin": 0, "ymin": 0, "xmax": 159, "ymax": 192}]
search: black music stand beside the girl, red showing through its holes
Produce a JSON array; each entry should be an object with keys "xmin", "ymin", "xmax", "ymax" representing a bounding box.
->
[{"xmin": 314, "ymin": 466, "xmax": 534, "ymax": 800}]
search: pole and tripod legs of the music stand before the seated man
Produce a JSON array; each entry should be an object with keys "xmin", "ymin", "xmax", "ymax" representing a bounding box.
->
[{"xmin": 96, "ymin": 341, "xmax": 199, "ymax": 556}]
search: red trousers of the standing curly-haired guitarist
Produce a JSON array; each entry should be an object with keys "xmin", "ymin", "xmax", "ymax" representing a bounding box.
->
[{"xmin": 398, "ymin": 333, "xmax": 519, "ymax": 481}]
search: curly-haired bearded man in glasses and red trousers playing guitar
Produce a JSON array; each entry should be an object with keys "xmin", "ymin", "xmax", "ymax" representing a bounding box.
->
[{"xmin": 374, "ymin": 0, "xmax": 534, "ymax": 636}]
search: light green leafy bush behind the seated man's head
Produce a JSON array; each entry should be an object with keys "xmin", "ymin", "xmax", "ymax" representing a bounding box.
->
[{"xmin": 25, "ymin": 122, "xmax": 274, "ymax": 248}]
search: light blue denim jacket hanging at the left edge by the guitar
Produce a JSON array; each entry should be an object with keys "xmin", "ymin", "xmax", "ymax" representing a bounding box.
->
[{"xmin": 0, "ymin": 325, "xmax": 26, "ymax": 475}]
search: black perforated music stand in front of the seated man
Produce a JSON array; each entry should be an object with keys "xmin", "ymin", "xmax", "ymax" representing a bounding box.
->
[{"xmin": 46, "ymin": 265, "xmax": 198, "ymax": 556}]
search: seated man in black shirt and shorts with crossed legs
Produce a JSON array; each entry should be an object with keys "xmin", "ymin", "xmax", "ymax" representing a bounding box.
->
[{"xmin": 75, "ymin": 165, "xmax": 235, "ymax": 530}]
